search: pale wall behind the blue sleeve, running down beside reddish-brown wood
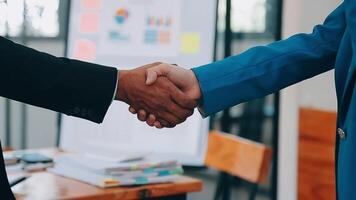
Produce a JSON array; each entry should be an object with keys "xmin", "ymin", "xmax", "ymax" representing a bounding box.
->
[{"xmin": 278, "ymin": 0, "xmax": 341, "ymax": 200}]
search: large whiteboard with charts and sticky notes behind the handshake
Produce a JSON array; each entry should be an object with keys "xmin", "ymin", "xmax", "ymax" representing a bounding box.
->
[{"xmin": 60, "ymin": 0, "xmax": 217, "ymax": 165}]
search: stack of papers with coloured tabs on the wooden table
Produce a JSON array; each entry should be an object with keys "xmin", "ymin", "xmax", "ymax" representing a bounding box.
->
[{"xmin": 49, "ymin": 154, "xmax": 183, "ymax": 187}]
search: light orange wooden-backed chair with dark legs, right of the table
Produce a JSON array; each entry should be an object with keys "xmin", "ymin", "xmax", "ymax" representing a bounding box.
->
[{"xmin": 205, "ymin": 131, "xmax": 272, "ymax": 200}]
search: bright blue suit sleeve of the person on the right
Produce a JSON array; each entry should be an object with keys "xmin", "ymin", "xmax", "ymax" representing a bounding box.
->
[{"xmin": 192, "ymin": 4, "xmax": 345, "ymax": 116}]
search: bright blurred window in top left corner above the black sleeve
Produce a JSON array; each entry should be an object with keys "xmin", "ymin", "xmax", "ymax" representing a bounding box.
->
[{"xmin": 0, "ymin": 0, "xmax": 67, "ymax": 38}]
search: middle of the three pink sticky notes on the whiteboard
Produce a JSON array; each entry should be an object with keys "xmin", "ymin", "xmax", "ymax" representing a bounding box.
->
[{"xmin": 79, "ymin": 13, "xmax": 99, "ymax": 33}]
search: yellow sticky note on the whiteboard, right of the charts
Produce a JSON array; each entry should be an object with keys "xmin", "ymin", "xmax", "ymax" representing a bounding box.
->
[{"xmin": 180, "ymin": 33, "xmax": 200, "ymax": 54}]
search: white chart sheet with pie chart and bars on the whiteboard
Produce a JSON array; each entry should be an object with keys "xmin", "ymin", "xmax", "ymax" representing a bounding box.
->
[{"xmin": 98, "ymin": 0, "xmax": 181, "ymax": 56}]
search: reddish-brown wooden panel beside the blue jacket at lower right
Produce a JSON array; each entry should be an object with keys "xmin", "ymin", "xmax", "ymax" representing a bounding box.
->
[{"xmin": 298, "ymin": 108, "xmax": 337, "ymax": 200}]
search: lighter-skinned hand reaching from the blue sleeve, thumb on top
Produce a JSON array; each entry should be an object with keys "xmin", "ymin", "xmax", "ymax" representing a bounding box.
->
[{"xmin": 129, "ymin": 63, "xmax": 201, "ymax": 128}]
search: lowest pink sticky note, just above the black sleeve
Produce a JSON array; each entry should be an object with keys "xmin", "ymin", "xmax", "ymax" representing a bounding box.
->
[{"xmin": 73, "ymin": 40, "xmax": 96, "ymax": 61}]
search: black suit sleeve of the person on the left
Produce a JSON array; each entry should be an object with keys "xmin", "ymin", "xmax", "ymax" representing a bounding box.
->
[{"xmin": 0, "ymin": 37, "xmax": 117, "ymax": 123}]
